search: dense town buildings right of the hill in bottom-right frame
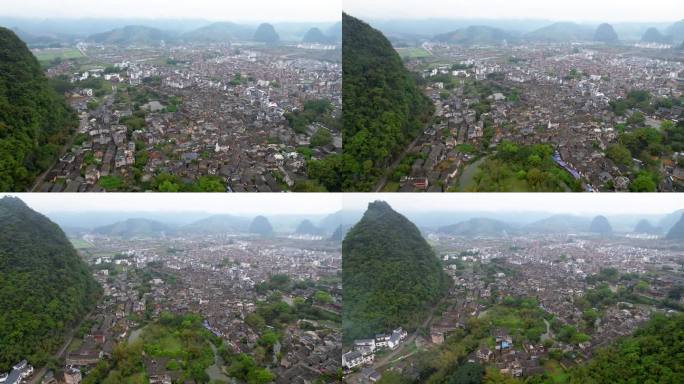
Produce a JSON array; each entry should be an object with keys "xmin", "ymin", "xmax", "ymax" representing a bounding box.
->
[{"xmin": 430, "ymin": 235, "xmax": 684, "ymax": 377}]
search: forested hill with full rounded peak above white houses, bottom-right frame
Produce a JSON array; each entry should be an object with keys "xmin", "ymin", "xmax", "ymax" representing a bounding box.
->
[{"xmin": 342, "ymin": 201, "xmax": 449, "ymax": 342}]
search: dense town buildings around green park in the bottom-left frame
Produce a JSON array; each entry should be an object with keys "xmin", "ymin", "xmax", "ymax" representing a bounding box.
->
[{"xmin": 84, "ymin": 235, "xmax": 342, "ymax": 383}]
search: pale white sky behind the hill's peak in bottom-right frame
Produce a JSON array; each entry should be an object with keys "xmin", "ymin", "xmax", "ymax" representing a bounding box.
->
[{"xmin": 344, "ymin": 193, "xmax": 684, "ymax": 215}]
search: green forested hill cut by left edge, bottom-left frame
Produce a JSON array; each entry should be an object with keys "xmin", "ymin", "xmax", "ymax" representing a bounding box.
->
[{"xmin": 0, "ymin": 197, "xmax": 101, "ymax": 372}]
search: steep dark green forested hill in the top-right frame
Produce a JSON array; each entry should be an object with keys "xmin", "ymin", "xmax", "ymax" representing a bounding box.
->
[{"xmin": 342, "ymin": 14, "xmax": 434, "ymax": 191}]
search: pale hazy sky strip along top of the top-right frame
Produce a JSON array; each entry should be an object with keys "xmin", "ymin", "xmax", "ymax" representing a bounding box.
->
[{"xmin": 342, "ymin": 0, "xmax": 684, "ymax": 22}]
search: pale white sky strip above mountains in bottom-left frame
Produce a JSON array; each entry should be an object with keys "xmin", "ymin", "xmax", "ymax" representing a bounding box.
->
[{"xmin": 4, "ymin": 193, "xmax": 342, "ymax": 215}]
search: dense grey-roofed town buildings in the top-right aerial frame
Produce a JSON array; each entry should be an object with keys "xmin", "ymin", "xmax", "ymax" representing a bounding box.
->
[{"xmin": 401, "ymin": 44, "xmax": 684, "ymax": 191}]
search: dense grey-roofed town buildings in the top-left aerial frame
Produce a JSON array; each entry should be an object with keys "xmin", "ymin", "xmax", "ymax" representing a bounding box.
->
[{"xmin": 35, "ymin": 46, "xmax": 342, "ymax": 192}]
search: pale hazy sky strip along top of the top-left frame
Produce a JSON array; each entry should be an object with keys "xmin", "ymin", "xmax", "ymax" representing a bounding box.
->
[{"xmin": 0, "ymin": 0, "xmax": 342, "ymax": 21}]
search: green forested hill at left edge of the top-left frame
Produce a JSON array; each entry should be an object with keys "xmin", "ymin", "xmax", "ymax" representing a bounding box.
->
[{"xmin": 0, "ymin": 27, "xmax": 78, "ymax": 191}]
